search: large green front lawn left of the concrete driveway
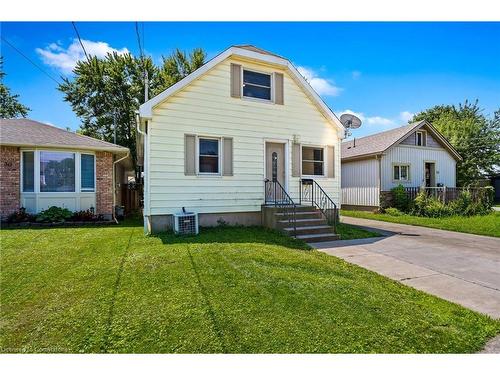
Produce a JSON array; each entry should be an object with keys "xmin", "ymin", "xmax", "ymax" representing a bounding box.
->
[{"xmin": 0, "ymin": 223, "xmax": 500, "ymax": 353}]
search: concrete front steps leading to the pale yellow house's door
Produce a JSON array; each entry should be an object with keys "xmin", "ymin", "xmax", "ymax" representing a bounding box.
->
[{"xmin": 263, "ymin": 206, "xmax": 339, "ymax": 243}]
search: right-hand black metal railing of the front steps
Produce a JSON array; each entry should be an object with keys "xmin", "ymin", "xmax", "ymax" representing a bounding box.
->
[{"xmin": 299, "ymin": 178, "xmax": 338, "ymax": 232}]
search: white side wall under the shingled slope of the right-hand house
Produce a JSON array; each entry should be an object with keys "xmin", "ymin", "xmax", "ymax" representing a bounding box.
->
[{"xmin": 342, "ymin": 159, "xmax": 380, "ymax": 206}]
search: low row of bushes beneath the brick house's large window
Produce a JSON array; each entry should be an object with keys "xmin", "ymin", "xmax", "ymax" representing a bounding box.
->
[{"xmin": 7, "ymin": 206, "xmax": 104, "ymax": 223}]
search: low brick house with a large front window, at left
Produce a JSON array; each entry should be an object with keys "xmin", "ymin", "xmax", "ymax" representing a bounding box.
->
[{"xmin": 0, "ymin": 119, "xmax": 133, "ymax": 220}]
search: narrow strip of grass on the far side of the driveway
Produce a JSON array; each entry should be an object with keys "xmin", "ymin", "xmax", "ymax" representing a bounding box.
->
[{"xmin": 340, "ymin": 210, "xmax": 500, "ymax": 237}]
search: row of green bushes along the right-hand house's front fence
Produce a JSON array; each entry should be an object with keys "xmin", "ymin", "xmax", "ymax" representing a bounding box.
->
[{"xmin": 385, "ymin": 185, "xmax": 494, "ymax": 217}]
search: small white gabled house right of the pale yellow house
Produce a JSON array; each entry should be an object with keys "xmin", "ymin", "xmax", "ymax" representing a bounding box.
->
[{"xmin": 341, "ymin": 121, "xmax": 462, "ymax": 209}]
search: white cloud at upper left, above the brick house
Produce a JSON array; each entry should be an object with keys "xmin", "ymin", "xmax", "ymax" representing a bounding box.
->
[{"xmin": 35, "ymin": 39, "xmax": 129, "ymax": 73}]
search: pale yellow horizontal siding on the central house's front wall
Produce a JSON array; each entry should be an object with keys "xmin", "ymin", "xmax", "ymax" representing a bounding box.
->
[{"xmin": 148, "ymin": 58, "xmax": 340, "ymax": 215}]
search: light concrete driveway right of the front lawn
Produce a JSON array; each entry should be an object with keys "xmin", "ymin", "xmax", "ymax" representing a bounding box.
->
[{"xmin": 312, "ymin": 217, "xmax": 500, "ymax": 319}]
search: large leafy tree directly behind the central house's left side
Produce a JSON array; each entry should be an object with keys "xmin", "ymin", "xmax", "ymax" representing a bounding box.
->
[{"xmin": 59, "ymin": 49, "xmax": 205, "ymax": 167}]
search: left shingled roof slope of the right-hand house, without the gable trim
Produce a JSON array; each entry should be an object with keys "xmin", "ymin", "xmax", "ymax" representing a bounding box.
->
[{"xmin": 342, "ymin": 121, "xmax": 425, "ymax": 159}]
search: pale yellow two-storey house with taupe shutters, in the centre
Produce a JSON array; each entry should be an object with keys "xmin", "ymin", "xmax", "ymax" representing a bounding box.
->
[{"xmin": 138, "ymin": 45, "xmax": 344, "ymax": 232}]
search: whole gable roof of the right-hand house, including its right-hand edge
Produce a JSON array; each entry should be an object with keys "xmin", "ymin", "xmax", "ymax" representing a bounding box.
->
[{"xmin": 342, "ymin": 120, "xmax": 462, "ymax": 160}]
